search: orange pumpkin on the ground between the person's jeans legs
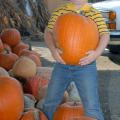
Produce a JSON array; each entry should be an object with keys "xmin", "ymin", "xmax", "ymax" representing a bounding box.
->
[{"xmin": 54, "ymin": 102, "xmax": 84, "ymax": 120}]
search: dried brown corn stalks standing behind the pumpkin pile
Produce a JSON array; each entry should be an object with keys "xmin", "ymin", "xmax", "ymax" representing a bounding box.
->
[{"xmin": 0, "ymin": 0, "xmax": 49, "ymax": 35}]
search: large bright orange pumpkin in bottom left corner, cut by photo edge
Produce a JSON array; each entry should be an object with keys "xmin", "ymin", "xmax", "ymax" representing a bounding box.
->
[{"xmin": 0, "ymin": 77, "xmax": 24, "ymax": 120}]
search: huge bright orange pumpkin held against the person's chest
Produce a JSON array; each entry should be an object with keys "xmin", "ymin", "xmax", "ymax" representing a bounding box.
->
[{"xmin": 54, "ymin": 13, "xmax": 99, "ymax": 65}]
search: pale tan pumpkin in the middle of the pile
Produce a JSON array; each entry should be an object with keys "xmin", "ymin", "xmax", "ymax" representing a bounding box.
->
[{"xmin": 12, "ymin": 56, "xmax": 37, "ymax": 78}]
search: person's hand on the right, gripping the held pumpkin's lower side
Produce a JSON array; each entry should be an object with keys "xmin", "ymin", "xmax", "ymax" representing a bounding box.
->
[{"xmin": 79, "ymin": 50, "xmax": 98, "ymax": 66}]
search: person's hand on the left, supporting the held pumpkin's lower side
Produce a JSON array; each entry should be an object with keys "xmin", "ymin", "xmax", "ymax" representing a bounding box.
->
[{"xmin": 52, "ymin": 48, "xmax": 65, "ymax": 64}]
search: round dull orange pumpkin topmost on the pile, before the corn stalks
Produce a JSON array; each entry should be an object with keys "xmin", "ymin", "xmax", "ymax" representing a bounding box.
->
[{"xmin": 1, "ymin": 28, "xmax": 21, "ymax": 46}]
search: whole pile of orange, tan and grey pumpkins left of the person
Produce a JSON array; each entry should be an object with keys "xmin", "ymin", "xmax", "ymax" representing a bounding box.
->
[{"xmin": 0, "ymin": 28, "xmax": 48, "ymax": 120}]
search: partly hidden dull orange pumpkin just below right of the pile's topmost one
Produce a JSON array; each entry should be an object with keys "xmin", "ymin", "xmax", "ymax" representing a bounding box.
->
[{"xmin": 12, "ymin": 42, "xmax": 29, "ymax": 56}]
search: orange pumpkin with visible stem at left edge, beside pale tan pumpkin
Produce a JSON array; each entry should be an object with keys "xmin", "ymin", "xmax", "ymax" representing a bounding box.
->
[{"xmin": 0, "ymin": 51, "xmax": 18, "ymax": 70}]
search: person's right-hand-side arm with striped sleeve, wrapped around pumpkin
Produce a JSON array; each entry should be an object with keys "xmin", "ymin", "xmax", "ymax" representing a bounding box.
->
[{"xmin": 79, "ymin": 5, "xmax": 110, "ymax": 65}]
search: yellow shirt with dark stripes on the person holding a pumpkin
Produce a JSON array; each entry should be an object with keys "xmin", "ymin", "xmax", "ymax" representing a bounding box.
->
[{"xmin": 48, "ymin": 3, "xmax": 109, "ymax": 35}]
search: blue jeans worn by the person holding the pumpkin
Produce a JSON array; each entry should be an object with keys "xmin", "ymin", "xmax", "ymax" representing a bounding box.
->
[{"xmin": 43, "ymin": 62, "xmax": 104, "ymax": 120}]
